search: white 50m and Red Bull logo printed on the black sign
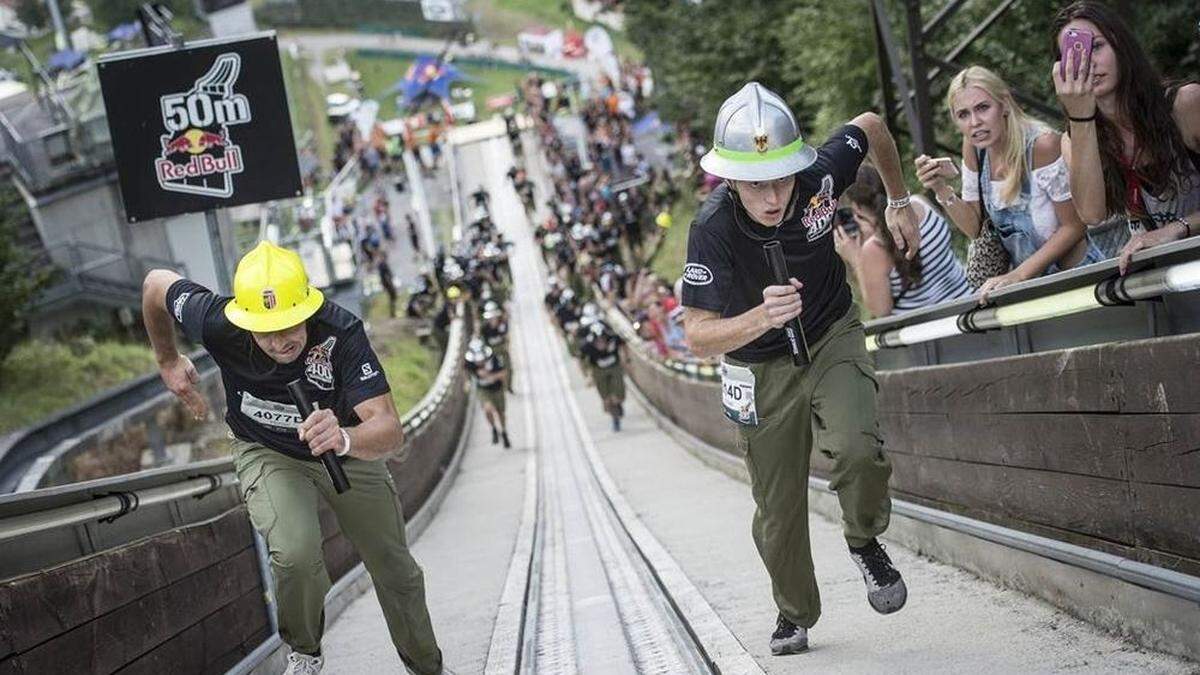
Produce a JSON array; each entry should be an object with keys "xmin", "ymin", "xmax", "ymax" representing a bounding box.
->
[{"xmin": 155, "ymin": 53, "xmax": 251, "ymax": 197}]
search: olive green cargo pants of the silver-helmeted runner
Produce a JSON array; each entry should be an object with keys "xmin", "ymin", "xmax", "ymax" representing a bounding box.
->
[{"xmin": 726, "ymin": 306, "xmax": 892, "ymax": 628}]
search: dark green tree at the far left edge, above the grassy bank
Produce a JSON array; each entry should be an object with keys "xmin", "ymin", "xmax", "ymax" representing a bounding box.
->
[{"xmin": 0, "ymin": 180, "xmax": 50, "ymax": 364}]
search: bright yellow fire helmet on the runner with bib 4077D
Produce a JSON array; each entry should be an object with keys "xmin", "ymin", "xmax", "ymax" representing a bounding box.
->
[{"xmin": 226, "ymin": 241, "xmax": 325, "ymax": 333}]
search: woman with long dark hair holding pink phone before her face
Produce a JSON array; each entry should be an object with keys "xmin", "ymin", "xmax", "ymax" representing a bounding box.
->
[{"xmin": 1051, "ymin": 2, "xmax": 1200, "ymax": 274}]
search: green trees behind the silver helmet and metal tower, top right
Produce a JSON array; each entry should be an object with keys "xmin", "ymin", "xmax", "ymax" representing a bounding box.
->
[{"xmin": 625, "ymin": 0, "xmax": 1200, "ymax": 156}]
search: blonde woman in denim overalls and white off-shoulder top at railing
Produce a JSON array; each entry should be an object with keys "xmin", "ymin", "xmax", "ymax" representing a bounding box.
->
[{"xmin": 917, "ymin": 66, "xmax": 1100, "ymax": 301}]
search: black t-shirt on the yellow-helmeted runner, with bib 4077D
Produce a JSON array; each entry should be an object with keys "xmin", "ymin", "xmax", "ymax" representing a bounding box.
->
[{"xmin": 167, "ymin": 279, "xmax": 391, "ymax": 461}]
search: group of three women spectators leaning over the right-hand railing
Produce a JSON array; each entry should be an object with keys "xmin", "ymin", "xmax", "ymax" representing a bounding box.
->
[{"xmin": 835, "ymin": 1, "xmax": 1200, "ymax": 316}]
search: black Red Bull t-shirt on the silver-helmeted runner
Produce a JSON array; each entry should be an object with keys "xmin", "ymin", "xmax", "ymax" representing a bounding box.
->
[{"xmin": 683, "ymin": 125, "xmax": 866, "ymax": 363}]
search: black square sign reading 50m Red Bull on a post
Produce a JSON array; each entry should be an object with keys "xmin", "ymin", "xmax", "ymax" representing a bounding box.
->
[{"xmin": 97, "ymin": 32, "xmax": 301, "ymax": 222}]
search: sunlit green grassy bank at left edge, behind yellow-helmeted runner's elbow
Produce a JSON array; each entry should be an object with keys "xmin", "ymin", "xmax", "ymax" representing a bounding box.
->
[{"xmin": 0, "ymin": 338, "xmax": 155, "ymax": 434}]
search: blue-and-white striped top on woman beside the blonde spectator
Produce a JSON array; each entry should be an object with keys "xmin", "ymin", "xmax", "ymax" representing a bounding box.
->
[{"xmin": 888, "ymin": 199, "xmax": 971, "ymax": 313}]
